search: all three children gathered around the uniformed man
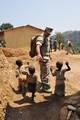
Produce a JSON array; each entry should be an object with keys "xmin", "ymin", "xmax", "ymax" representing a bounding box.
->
[{"xmin": 16, "ymin": 60, "xmax": 71, "ymax": 102}]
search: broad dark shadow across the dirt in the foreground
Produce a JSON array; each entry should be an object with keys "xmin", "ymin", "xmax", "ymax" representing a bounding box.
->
[{"xmin": 5, "ymin": 91, "xmax": 80, "ymax": 120}]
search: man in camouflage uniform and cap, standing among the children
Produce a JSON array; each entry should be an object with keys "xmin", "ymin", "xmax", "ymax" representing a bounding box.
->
[{"xmin": 36, "ymin": 27, "xmax": 53, "ymax": 92}]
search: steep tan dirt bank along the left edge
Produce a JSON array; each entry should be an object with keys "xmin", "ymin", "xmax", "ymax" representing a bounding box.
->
[{"xmin": 0, "ymin": 49, "xmax": 13, "ymax": 120}]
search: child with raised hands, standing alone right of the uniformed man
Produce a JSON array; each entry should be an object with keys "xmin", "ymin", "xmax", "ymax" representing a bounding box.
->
[{"xmin": 50, "ymin": 61, "xmax": 71, "ymax": 96}]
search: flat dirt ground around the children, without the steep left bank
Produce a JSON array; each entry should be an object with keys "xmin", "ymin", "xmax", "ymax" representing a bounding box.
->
[{"xmin": 0, "ymin": 51, "xmax": 80, "ymax": 120}]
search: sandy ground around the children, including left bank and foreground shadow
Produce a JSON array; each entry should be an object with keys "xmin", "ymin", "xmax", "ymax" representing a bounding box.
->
[{"xmin": 0, "ymin": 50, "xmax": 80, "ymax": 120}]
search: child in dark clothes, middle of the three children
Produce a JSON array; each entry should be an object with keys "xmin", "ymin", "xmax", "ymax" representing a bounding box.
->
[{"xmin": 23, "ymin": 65, "xmax": 37, "ymax": 102}]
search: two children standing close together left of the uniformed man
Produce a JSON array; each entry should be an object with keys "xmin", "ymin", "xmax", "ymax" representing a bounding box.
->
[{"xmin": 16, "ymin": 60, "xmax": 37, "ymax": 101}]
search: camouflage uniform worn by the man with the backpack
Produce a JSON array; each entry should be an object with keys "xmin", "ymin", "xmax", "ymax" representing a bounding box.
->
[{"xmin": 36, "ymin": 34, "xmax": 50, "ymax": 89}]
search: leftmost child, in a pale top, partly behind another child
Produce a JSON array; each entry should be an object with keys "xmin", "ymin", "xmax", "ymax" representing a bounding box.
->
[{"xmin": 16, "ymin": 59, "xmax": 29, "ymax": 92}]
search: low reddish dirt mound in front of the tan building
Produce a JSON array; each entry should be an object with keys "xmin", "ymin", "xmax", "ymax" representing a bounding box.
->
[{"xmin": 2, "ymin": 48, "xmax": 26, "ymax": 57}]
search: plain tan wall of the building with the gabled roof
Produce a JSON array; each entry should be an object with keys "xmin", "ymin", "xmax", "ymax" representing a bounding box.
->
[{"xmin": 4, "ymin": 26, "xmax": 42, "ymax": 48}]
